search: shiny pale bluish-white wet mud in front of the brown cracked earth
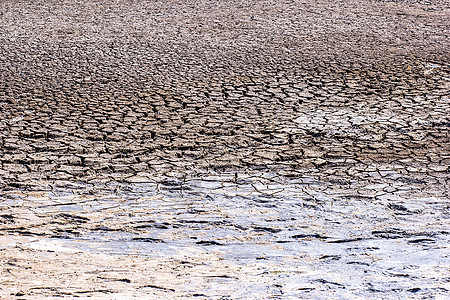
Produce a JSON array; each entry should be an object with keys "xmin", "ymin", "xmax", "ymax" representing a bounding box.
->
[{"xmin": 2, "ymin": 174, "xmax": 450, "ymax": 299}]
